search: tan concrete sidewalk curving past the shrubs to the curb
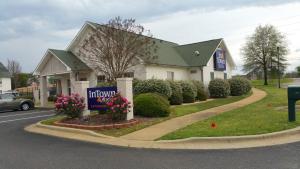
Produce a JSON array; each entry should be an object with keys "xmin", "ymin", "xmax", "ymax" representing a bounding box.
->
[{"xmin": 121, "ymin": 88, "xmax": 266, "ymax": 141}]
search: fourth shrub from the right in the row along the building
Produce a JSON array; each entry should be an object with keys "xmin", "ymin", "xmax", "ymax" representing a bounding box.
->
[{"xmin": 179, "ymin": 81, "xmax": 197, "ymax": 103}]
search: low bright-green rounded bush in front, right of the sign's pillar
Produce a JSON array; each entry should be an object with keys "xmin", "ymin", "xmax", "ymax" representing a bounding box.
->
[{"xmin": 133, "ymin": 93, "xmax": 170, "ymax": 117}]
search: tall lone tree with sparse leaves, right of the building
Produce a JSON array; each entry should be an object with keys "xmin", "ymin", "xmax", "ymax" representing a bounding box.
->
[{"xmin": 241, "ymin": 25, "xmax": 288, "ymax": 85}]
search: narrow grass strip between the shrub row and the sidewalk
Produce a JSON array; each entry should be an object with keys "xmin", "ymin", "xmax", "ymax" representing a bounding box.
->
[{"xmin": 42, "ymin": 94, "xmax": 250, "ymax": 137}]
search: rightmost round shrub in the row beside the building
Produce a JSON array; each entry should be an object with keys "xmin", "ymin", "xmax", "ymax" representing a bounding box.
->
[{"xmin": 228, "ymin": 77, "xmax": 251, "ymax": 96}]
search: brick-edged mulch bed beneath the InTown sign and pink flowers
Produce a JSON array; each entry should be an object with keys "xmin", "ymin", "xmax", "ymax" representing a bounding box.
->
[{"xmin": 54, "ymin": 114, "xmax": 143, "ymax": 130}]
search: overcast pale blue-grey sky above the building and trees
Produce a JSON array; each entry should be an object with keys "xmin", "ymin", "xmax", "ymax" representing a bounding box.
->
[{"xmin": 0, "ymin": 0, "xmax": 300, "ymax": 73}]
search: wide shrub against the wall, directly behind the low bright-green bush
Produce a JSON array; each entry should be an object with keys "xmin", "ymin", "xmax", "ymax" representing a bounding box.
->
[{"xmin": 133, "ymin": 79, "xmax": 172, "ymax": 98}]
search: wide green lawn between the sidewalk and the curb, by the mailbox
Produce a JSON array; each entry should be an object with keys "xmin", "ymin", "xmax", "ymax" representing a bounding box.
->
[{"xmin": 161, "ymin": 80, "xmax": 300, "ymax": 140}]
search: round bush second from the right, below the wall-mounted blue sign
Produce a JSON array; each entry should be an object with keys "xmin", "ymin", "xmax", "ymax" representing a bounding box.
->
[{"xmin": 208, "ymin": 79, "xmax": 230, "ymax": 98}]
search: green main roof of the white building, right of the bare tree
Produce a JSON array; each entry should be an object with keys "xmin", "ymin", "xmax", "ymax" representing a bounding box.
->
[{"xmin": 87, "ymin": 21, "xmax": 222, "ymax": 67}]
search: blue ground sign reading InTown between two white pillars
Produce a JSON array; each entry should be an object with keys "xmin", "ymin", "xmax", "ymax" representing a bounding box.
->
[{"xmin": 87, "ymin": 87, "xmax": 117, "ymax": 110}]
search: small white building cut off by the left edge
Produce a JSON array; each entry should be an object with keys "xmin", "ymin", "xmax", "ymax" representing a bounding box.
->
[{"xmin": 0, "ymin": 62, "xmax": 11, "ymax": 94}]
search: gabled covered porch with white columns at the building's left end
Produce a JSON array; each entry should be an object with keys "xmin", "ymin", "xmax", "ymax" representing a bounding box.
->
[{"xmin": 34, "ymin": 49, "xmax": 97, "ymax": 107}]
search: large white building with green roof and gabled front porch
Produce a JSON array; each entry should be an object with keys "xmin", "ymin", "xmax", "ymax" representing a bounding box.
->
[{"xmin": 34, "ymin": 22, "xmax": 235, "ymax": 104}]
